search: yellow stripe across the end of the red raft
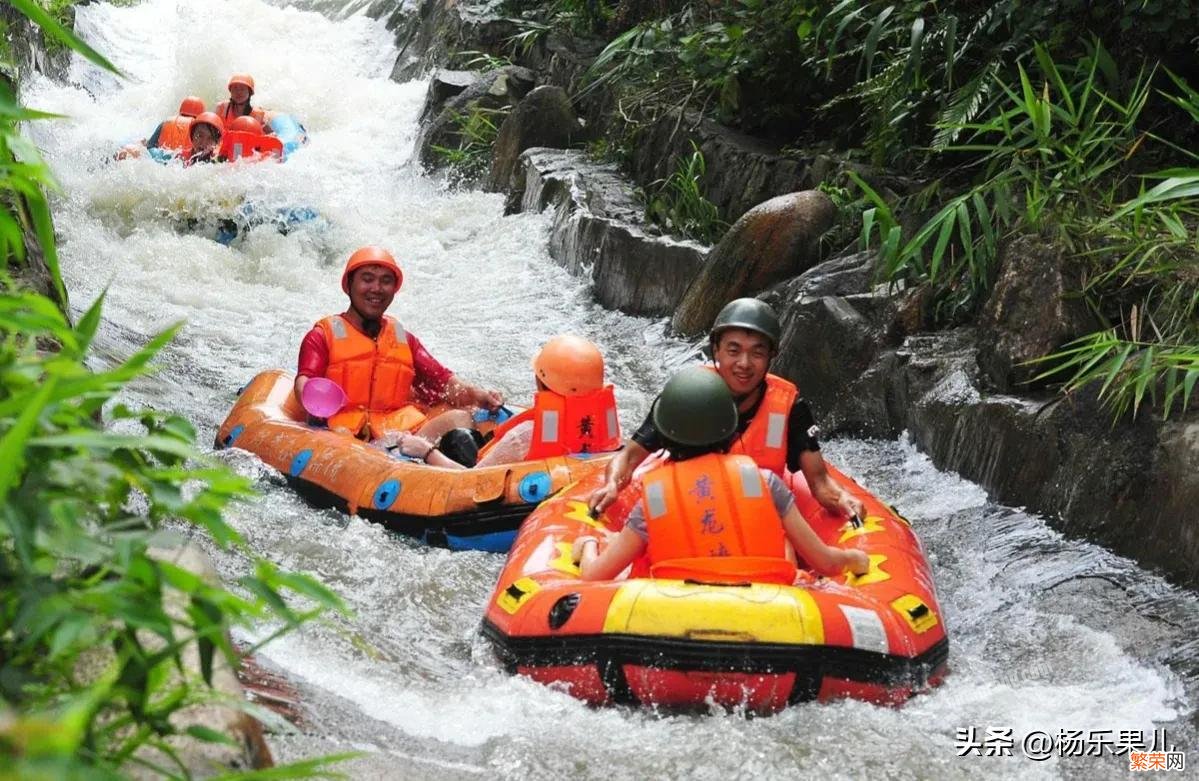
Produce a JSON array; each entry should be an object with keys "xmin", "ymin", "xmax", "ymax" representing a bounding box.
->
[{"xmin": 603, "ymin": 579, "xmax": 824, "ymax": 645}]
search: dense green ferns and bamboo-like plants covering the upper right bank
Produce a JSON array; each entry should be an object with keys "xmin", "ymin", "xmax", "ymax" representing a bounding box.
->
[{"xmin": 505, "ymin": 0, "xmax": 1199, "ymax": 422}]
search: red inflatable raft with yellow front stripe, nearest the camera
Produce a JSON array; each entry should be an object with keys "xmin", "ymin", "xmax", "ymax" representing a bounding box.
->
[{"xmin": 481, "ymin": 467, "xmax": 948, "ymax": 713}]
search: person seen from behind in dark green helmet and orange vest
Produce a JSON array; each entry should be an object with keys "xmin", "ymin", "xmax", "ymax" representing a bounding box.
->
[{"xmin": 573, "ymin": 366, "xmax": 869, "ymax": 584}]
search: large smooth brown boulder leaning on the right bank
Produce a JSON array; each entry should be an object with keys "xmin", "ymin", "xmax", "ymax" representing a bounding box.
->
[{"xmin": 670, "ymin": 190, "xmax": 837, "ymax": 334}]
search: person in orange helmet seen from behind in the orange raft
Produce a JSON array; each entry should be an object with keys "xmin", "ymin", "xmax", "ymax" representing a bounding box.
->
[{"xmin": 478, "ymin": 334, "xmax": 620, "ymax": 467}]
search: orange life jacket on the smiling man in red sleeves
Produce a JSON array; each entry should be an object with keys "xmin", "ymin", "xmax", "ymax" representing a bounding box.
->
[{"xmin": 317, "ymin": 314, "xmax": 416, "ymax": 413}]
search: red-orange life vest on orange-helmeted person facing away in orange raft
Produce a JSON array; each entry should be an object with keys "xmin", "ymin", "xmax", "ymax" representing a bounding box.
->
[{"xmin": 478, "ymin": 385, "xmax": 620, "ymax": 458}]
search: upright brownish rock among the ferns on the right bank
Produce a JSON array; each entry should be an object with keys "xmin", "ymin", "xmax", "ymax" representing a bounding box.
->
[{"xmin": 978, "ymin": 236, "xmax": 1092, "ymax": 390}]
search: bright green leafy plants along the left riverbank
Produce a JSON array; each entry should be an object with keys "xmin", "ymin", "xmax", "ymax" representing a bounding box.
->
[{"xmin": 0, "ymin": 0, "xmax": 345, "ymax": 779}]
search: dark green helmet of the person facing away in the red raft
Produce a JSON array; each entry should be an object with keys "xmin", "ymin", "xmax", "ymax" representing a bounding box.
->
[{"xmin": 653, "ymin": 366, "xmax": 737, "ymax": 446}]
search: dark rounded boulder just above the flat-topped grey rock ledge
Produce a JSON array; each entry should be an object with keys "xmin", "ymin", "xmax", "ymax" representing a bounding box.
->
[{"xmin": 487, "ymin": 85, "xmax": 579, "ymax": 191}]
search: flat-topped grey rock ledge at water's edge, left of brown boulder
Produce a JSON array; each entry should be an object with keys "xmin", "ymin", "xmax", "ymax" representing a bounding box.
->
[{"xmin": 510, "ymin": 149, "xmax": 704, "ymax": 316}]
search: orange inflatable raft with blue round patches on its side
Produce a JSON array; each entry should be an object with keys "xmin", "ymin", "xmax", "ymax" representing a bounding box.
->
[{"xmin": 216, "ymin": 370, "xmax": 611, "ymax": 553}]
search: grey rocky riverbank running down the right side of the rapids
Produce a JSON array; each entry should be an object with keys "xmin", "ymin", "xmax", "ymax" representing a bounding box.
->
[{"xmin": 374, "ymin": 0, "xmax": 1199, "ymax": 587}]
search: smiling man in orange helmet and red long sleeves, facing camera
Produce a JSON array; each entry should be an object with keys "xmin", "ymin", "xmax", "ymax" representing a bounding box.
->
[{"xmin": 295, "ymin": 246, "xmax": 504, "ymax": 465}]
